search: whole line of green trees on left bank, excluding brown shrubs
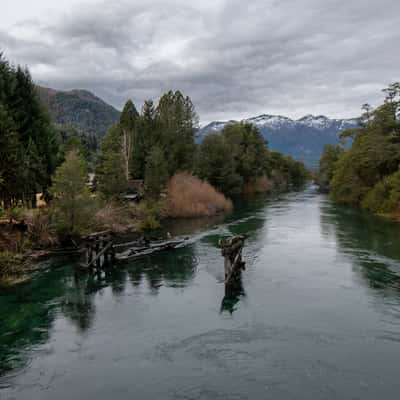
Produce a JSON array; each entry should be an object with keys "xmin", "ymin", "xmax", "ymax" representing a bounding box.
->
[{"xmin": 0, "ymin": 56, "xmax": 308, "ymax": 239}]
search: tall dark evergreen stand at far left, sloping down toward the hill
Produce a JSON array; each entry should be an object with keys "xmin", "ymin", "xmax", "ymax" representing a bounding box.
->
[{"xmin": 0, "ymin": 53, "xmax": 97, "ymax": 208}]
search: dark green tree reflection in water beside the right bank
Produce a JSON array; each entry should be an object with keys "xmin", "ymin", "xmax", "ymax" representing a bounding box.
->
[{"xmin": 320, "ymin": 203, "xmax": 400, "ymax": 294}]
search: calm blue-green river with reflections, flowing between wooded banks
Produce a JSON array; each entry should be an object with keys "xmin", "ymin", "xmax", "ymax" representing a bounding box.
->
[{"xmin": 0, "ymin": 186, "xmax": 400, "ymax": 400}]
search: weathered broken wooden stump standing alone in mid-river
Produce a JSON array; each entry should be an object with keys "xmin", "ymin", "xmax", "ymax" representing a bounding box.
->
[{"xmin": 219, "ymin": 235, "xmax": 245, "ymax": 287}]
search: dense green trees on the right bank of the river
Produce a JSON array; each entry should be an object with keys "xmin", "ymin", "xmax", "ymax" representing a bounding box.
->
[{"xmin": 318, "ymin": 83, "xmax": 400, "ymax": 216}]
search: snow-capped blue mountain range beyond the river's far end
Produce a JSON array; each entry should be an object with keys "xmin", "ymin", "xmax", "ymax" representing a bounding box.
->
[{"xmin": 196, "ymin": 114, "xmax": 358, "ymax": 166}]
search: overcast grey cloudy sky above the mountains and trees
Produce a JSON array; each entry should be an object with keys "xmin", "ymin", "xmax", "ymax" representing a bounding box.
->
[{"xmin": 0, "ymin": 0, "xmax": 400, "ymax": 123}]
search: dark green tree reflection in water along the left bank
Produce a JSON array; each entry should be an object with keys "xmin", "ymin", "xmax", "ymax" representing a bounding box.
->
[{"xmin": 0, "ymin": 246, "xmax": 197, "ymax": 376}]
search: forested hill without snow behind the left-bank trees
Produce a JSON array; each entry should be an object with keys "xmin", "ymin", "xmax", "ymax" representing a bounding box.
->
[{"xmin": 36, "ymin": 86, "xmax": 121, "ymax": 139}]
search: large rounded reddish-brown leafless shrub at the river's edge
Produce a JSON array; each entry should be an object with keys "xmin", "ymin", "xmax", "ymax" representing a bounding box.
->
[{"xmin": 166, "ymin": 172, "xmax": 232, "ymax": 218}]
